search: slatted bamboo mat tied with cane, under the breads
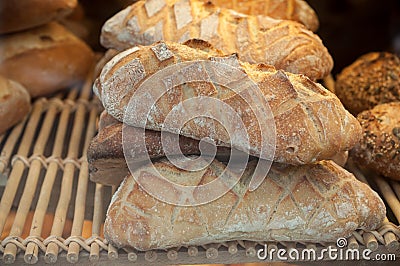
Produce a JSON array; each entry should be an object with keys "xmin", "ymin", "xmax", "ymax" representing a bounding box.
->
[{"xmin": 0, "ymin": 72, "xmax": 400, "ymax": 265}]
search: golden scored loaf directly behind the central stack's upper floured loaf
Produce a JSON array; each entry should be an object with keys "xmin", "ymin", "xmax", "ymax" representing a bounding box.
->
[{"xmin": 101, "ymin": 0, "xmax": 333, "ymax": 80}]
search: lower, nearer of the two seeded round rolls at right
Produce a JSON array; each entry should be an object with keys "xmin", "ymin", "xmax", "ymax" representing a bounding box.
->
[{"xmin": 350, "ymin": 102, "xmax": 400, "ymax": 180}]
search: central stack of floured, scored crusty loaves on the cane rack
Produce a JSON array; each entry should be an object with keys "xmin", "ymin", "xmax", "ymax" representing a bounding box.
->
[{"xmin": 88, "ymin": 0, "xmax": 385, "ymax": 250}]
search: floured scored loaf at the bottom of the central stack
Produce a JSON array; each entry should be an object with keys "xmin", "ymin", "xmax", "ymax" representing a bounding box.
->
[{"xmin": 104, "ymin": 157, "xmax": 386, "ymax": 250}]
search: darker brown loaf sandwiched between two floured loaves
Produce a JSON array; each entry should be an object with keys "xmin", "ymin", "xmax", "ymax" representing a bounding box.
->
[{"xmin": 87, "ymin": 120, "xmax": 230, "ymax": 185}]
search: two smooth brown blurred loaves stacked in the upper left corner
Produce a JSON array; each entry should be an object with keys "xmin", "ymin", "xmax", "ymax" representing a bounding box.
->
[{"xmin": 0, "ymin": 0, "xmax": 94, "ymax": 97}]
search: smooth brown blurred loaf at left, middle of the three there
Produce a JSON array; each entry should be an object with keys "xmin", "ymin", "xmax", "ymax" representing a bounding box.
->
[{"xmin": 0, "ymin": 22, "xmax": 94, "ymax": 97}]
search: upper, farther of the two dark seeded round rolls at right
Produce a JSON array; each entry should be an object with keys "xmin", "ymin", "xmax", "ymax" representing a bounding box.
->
[{"xmin": 335, "ymin": 52, "xmax": 400, "ymax": 115}]
